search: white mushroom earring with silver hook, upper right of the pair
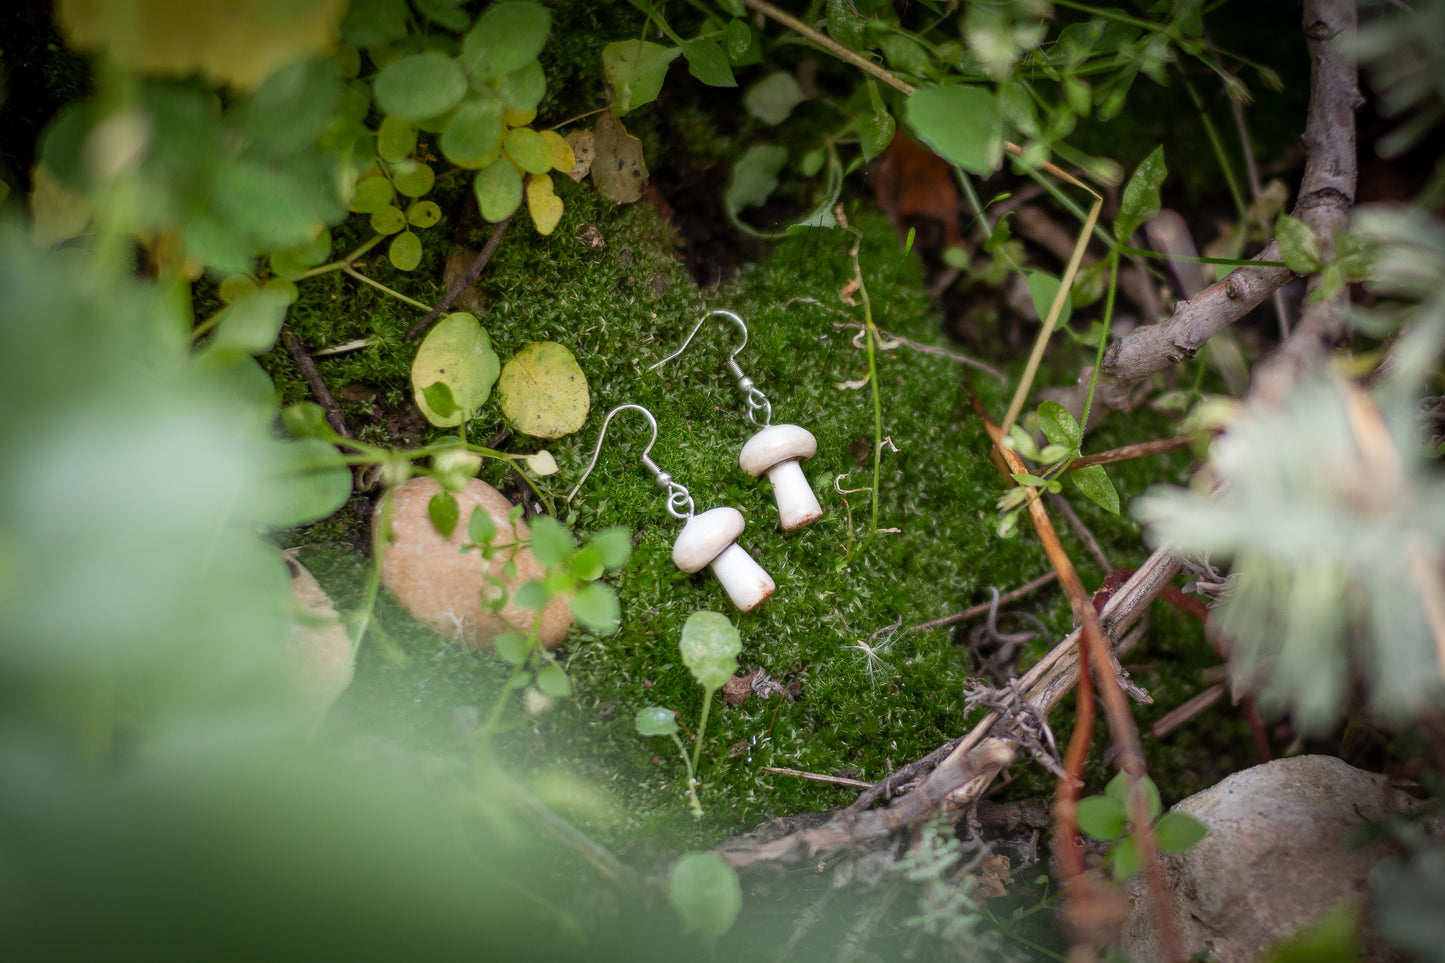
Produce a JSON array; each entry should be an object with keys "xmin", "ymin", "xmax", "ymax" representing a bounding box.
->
[{"xmin": 647, "ymin": 308, "xmax": 822, "ymax": 532}]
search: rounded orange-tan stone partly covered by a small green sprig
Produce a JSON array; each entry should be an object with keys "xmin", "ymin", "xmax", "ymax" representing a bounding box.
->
[{"xmin": 371, "ymin": 477, "xmax": 572, "ymax": 651}]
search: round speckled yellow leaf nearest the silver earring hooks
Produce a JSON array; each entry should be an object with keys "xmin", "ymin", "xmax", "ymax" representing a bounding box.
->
[{"xmin": 497, "ymin": 341, "xmax": 592, "ymax": 438}]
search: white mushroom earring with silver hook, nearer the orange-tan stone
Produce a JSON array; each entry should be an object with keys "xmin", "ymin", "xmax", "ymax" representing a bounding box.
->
[{"xmin": 566, "ymin": 405, "xmax": 776, "ymax": 612}]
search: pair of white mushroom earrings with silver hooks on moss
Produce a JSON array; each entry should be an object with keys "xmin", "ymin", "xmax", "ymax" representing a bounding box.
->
[{"xmin": 566, "ymin": 309, "xmax": 822, "ymax": 612}]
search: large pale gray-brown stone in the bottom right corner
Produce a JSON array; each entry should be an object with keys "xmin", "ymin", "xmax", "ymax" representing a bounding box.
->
[{"xmin": 1121, "ymin": 756, "xmax": 1445, "ymax": 963}]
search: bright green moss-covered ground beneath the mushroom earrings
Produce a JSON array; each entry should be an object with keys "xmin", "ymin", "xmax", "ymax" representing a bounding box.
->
[{"xmin": 267, "ymin": 167, "xmax": 1231, "ymax": 847}]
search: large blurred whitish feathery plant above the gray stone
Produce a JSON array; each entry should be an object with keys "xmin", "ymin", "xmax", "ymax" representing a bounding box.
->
[{"xmin": 1136, "ymin": 377, "xmax": 1445, "ymax": 732}]
